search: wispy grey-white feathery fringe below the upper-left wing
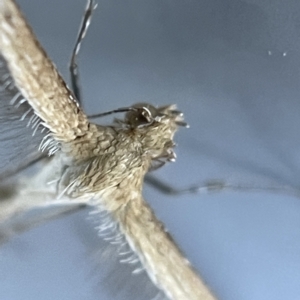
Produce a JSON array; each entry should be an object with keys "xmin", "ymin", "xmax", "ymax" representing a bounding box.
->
[{"xmin": 0, "ymin": 56, "xmax": 46, "ymax": 181}]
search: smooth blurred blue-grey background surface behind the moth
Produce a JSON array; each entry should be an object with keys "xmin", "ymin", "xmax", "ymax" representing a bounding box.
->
[{"xmin": 0, "ymin": 0, "xmax": 300, "ymax": 300}]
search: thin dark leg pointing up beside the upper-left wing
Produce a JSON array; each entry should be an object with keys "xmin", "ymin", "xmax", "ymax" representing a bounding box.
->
[{"xmin": 69, "ymin": 0, "xmax": 97, "ymax": 104}]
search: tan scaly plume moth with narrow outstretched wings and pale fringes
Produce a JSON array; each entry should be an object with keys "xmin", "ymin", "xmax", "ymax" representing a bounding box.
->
[{"xmin": 0, "ymin": 1, "xmax": 213, "ymax": 300}]
